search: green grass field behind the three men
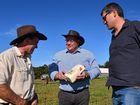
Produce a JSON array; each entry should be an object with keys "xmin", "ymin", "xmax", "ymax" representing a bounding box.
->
[{"xmin": 36, "ymin": 78, "xmax": 111, "ymax": 105}]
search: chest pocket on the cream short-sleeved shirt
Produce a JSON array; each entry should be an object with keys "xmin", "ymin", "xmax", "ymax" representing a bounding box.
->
[{"xmin": 16, "ymin": 67, "xmax": 29, "ymax": 82}]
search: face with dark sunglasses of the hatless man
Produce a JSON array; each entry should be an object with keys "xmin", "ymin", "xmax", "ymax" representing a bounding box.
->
[{"xmin": 102, "ymin": 11, "xmax": 115, "ymax": 29}]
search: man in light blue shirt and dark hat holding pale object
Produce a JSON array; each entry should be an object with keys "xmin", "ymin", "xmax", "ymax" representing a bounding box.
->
[{"xmin": 49, "ymin": 30, "xmax": 100, "ymax": 105}]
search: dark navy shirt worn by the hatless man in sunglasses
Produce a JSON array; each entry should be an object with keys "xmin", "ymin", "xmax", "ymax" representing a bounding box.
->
[{"xmin": 107, "ymin": 20, "xmax": 140, "ymax": 86}]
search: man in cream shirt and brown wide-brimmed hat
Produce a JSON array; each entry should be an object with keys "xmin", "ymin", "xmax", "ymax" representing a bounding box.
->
[{"xmin": 0, "ymin": 25, "xmax": 47, "ymax": 105}]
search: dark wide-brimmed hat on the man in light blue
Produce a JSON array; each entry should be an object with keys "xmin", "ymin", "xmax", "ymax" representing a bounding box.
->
[{"xmin": 62, "ymin": 30, "xmax": 85, "ymax": 46}]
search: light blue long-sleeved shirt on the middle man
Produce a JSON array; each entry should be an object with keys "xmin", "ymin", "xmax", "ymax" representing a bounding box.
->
[{"xmin": 49, "ymin": 48, "xmax": 101, "ymax": 91}]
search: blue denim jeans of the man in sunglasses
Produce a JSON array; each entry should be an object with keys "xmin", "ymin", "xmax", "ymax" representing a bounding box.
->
[{"xmin": 112, "ymin": 86, "xmax": 140, "ymax": 105}]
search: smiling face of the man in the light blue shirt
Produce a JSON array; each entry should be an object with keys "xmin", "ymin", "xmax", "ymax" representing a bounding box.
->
[{"xmin": 66, "ymin": 36, "xmax": 79, "ymax": 53}]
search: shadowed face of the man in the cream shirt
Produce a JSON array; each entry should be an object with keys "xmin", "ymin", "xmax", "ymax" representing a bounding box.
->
[{"xmin": 26, "ymin": 37, "xmax": 39, "ymax": 54}]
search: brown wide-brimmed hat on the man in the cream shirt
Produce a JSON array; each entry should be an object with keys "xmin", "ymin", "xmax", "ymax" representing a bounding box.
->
[{"xmin": 10, "ymin": 25, "xmax": 47, "ymax": 45}]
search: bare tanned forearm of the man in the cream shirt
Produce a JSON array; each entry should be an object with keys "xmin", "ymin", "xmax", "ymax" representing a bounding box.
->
[{"xmin": 0, "ymin": 84, "xmax": 28, "ymax": 105}]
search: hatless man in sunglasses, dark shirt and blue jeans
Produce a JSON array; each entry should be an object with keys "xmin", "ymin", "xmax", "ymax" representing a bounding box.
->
[{"xmin": 101, "ymin": 3, "xmax": 140, "ymax": 105}]
